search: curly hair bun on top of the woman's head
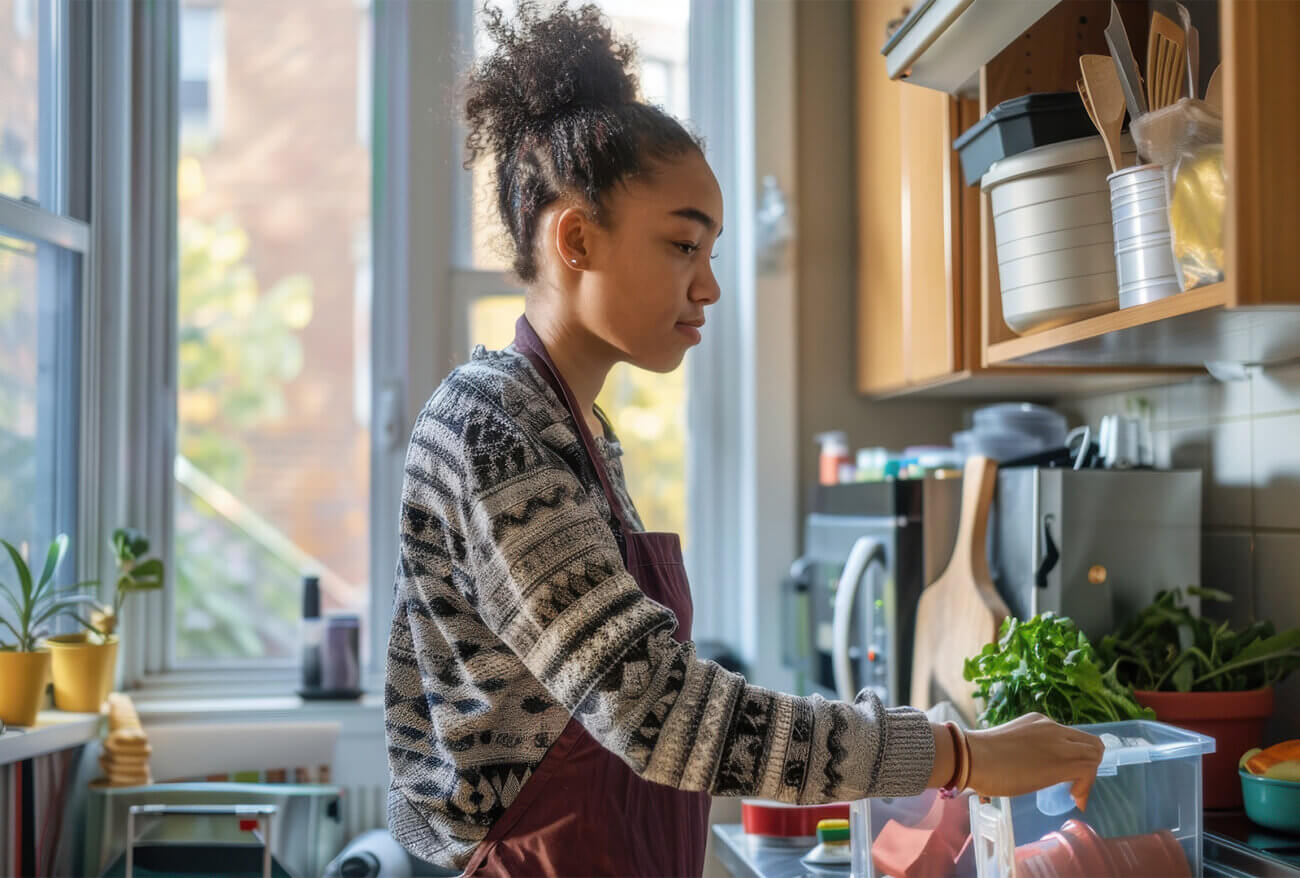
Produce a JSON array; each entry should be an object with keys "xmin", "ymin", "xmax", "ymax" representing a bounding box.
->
[{"xmin": 465, "ymin": 0, "xmax": 637, "ymax": 159}]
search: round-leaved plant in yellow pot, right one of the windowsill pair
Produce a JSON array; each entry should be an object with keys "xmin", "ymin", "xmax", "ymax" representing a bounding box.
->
[{"xmin": 47, "ymin": 528, "xmax": 164, "ymax": 712}]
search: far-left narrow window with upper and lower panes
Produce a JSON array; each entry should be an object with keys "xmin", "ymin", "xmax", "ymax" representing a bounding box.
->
[{"xmin": 0, "ymin": 0, "xmax": 91, "ymax": 619}]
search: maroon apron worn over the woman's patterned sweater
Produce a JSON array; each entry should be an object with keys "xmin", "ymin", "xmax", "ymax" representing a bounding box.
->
[{"xmin": 464, "ymin": 317, "xmax": 711, "ymax": 878}]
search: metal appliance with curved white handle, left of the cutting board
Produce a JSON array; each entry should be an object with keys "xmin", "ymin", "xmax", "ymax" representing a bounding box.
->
[{"xmin": 784, "ymin": 473, "xmax": 961, "ymax": 705}]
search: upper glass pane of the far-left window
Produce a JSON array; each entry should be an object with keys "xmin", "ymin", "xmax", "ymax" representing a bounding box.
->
[{"xmin": 0, "ymin": 0, "xmax": 47, "ymax": 202}]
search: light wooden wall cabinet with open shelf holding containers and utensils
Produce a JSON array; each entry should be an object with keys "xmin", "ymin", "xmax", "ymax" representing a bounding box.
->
[{"xmin": 855, "ymin": 0, "xmax": 1300, "ymax": 397}]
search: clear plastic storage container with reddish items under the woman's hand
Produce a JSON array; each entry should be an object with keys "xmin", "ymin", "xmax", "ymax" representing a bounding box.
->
[{"xmin": 850, "ymin": 721, "xmax": 1214, "ymax": 878}]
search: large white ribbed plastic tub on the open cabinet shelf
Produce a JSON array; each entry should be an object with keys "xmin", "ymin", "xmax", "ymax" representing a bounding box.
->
[{"xmin": 980, "ymin": 135, "xmax": 1134, "ymax": 334}]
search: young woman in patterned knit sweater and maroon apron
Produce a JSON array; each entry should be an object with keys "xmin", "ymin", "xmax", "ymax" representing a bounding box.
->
[{"xmin": 386, "ymin": 3, "xmax": 1101, "ymax": 877}]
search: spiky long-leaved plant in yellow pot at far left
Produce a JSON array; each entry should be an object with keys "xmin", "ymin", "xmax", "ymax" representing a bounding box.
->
[{"xmin": 0, "ymin": 533, "xmax": 96, "ymax": 726}]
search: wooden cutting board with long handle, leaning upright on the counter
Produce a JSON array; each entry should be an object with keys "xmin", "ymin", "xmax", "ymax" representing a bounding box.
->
[{"xmin": 911, "ymin": 457, "xmax": 1009, "ymax": 725}]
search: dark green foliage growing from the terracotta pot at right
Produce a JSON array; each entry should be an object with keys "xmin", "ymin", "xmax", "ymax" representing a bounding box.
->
[{"xmin": 1099, "ymin": 588, "xmax": 1300, "ymax": 692}]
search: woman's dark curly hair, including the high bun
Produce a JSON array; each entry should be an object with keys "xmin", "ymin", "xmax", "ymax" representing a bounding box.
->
[{"xmin": 464, "ymin": 0, "xmax": 703, "ymax": 282}]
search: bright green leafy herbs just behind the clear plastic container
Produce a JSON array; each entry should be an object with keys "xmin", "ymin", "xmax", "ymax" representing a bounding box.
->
[{"xmin": 965, "ymin": 613, "xmax": 1154, "ymax": 726}]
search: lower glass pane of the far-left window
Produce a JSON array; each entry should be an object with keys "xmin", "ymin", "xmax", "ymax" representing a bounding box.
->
[{"xmin": 0, "ymin": 230, "xmax": 82, "ymax": 577}]
